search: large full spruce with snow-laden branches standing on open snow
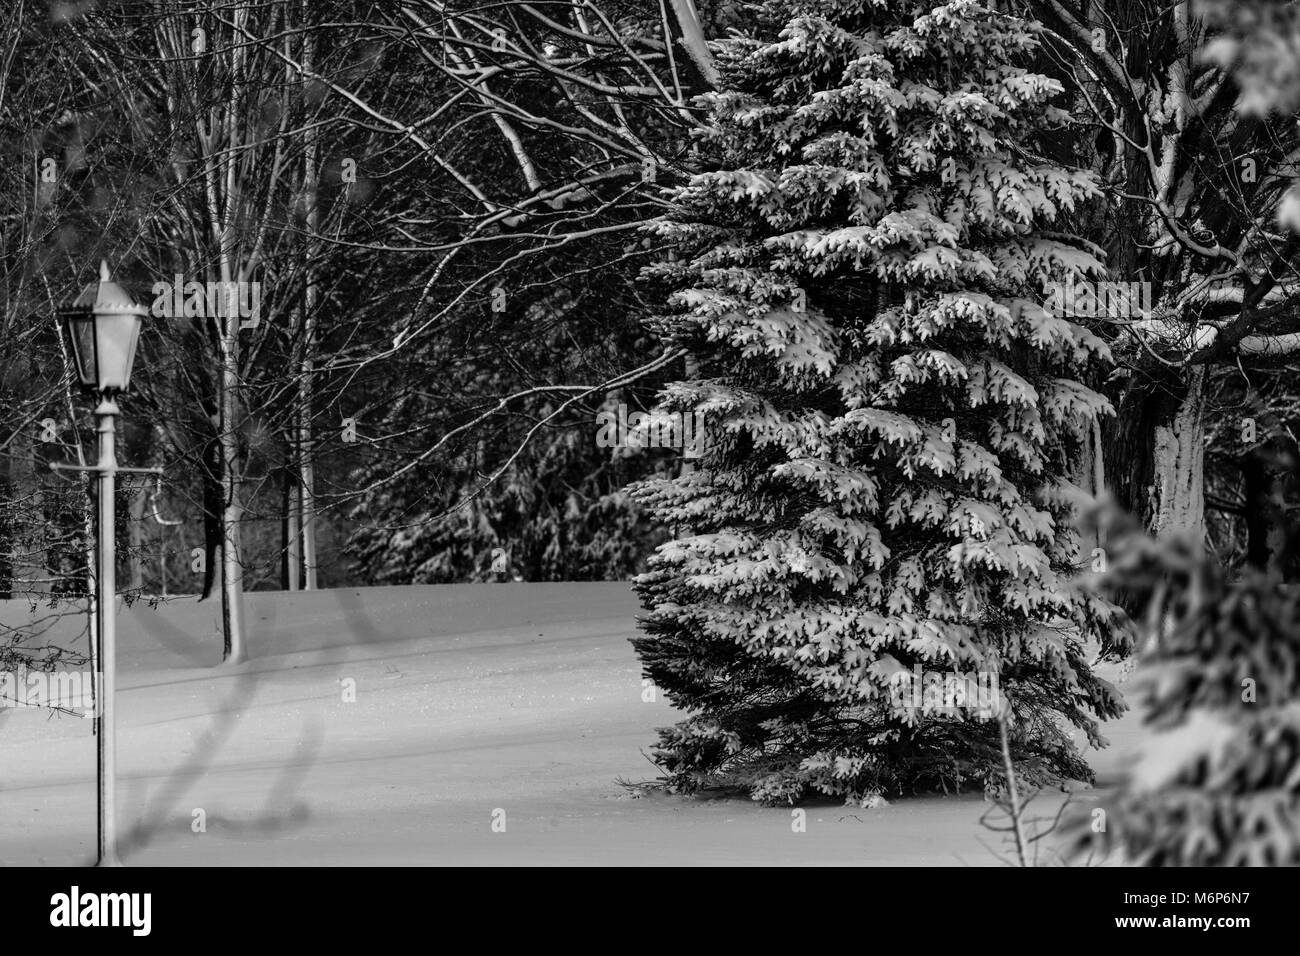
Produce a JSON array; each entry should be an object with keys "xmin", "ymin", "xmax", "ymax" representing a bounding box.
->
[{"xmin": 634, "ymin": 0, "xmax": 1123, "ymax": 801}]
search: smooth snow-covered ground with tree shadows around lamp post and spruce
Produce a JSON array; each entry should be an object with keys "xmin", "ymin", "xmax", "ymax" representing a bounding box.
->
[{"xmin": 0, "ymin": 584, "xmax": 1136, "ymax": 865}]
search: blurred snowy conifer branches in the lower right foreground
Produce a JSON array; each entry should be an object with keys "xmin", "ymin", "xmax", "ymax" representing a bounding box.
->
[{"xmin": 1066, "ymin": 515, "xmax": 1300, "ymax": 866}]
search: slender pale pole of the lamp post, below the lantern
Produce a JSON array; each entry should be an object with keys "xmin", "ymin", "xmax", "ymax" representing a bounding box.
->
[{"xmin": 95, "ymin": 395, "xmax": 121, "ymax": 866}]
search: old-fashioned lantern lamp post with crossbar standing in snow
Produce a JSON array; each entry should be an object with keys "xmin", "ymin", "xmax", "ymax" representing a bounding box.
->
[{"xmin": 52, "ymin": 263, "xmax": 161, "ymax": 866}]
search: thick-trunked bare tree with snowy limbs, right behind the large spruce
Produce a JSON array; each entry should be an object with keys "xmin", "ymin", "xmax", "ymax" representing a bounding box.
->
[{"xmin": 1027, "ymin": 0, "xmax": 1300, "ymax": 535}]
